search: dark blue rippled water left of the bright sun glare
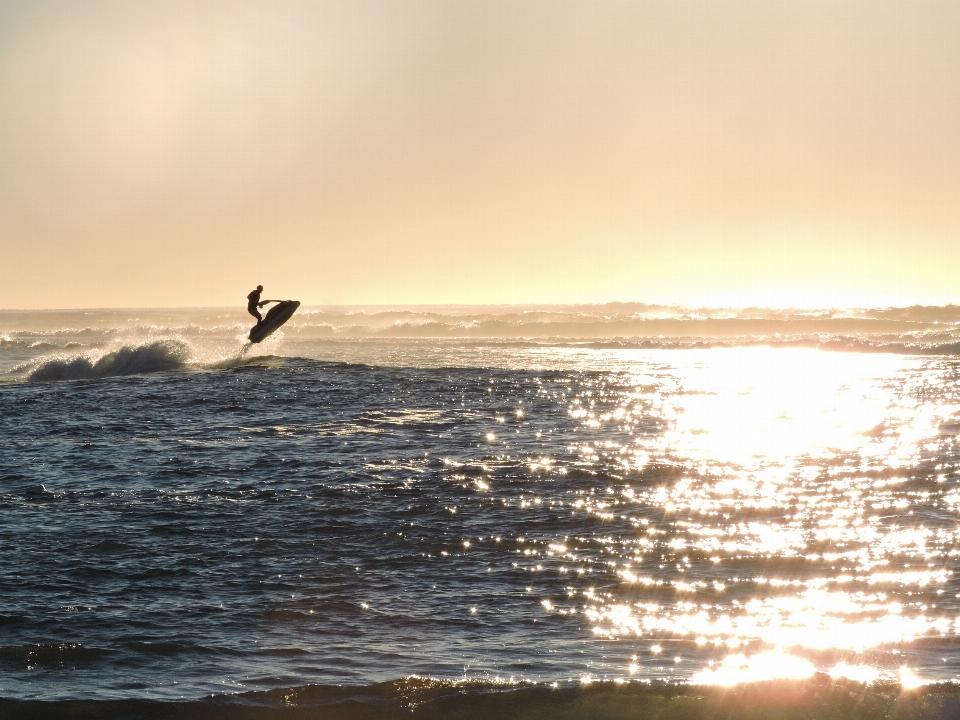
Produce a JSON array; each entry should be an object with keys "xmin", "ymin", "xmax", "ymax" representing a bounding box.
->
[{"xmin": 0, "ymin": 358, "xmax": 652, "ymax": 697}]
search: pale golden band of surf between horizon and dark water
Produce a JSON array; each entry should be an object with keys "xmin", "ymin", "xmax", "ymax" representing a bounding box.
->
[{"xmin": 0, "ymin": 303, "xmax": 960, "ymax": 382}]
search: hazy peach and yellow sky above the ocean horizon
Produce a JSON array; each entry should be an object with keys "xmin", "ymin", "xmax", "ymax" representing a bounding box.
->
[{"xmin": 0, "ymin": 0, "xmax": 960, "ymax": 308}]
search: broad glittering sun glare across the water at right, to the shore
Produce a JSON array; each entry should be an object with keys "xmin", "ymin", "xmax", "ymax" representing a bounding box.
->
[{"xmin": 570, "ymin": 348, "xmax": 960, "ymax": 686}]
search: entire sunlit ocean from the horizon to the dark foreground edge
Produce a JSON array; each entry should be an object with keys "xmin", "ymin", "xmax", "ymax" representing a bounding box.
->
[{"xmin": 0, "ymin": 304, "xmax": 960, "ymax": 716}]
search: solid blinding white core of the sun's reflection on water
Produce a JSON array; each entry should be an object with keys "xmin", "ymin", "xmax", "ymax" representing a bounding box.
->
[{"xmin": 664, "ymin": 348, "xmax": 930, "ymax": 466}]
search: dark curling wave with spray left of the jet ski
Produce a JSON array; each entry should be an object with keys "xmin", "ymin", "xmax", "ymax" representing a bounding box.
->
[{"xmin": 27, "ymin": 340, "xmax": 190, "ymax": 382}]
